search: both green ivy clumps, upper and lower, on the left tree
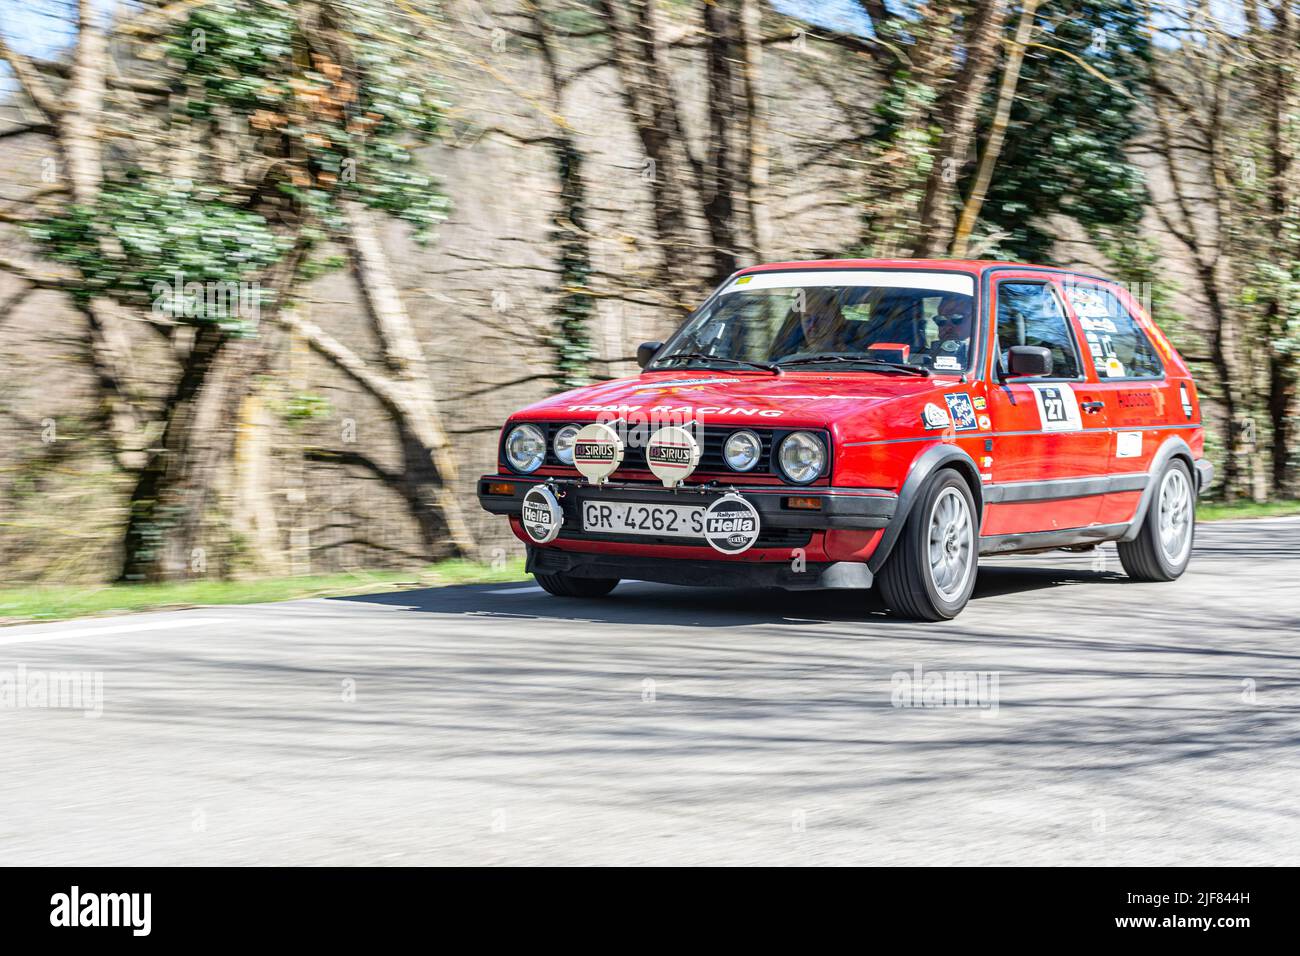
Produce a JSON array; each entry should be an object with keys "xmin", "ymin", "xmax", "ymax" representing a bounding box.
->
[{"xmin": 31, "ymin": 0, "xmax": 449, "ymax": 323}]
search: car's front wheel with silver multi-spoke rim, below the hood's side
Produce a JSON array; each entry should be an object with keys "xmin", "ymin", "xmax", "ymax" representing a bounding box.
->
[{"xmin": 879, "ymin": 468, "xmax": 979, "ymax": 620}]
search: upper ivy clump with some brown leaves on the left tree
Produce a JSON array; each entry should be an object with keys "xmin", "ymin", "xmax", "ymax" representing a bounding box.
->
[{"xmin": 169, "ymin": 0, "xmax": 449, "ymax": 239}]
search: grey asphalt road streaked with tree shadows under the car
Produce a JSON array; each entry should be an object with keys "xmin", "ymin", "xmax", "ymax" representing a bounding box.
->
[{"xmin": 0, "ymin": 519, "xmax": 1300, "ymax": 865}]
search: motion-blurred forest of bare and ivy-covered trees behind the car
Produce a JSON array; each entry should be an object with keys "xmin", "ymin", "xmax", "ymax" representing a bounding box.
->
[{"xmin": 0, "ymin": 0, "xmax": 1300, "ymax": 584}]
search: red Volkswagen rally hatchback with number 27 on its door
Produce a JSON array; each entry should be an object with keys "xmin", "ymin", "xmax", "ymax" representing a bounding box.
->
[{"xmin": 478, "ymin": 259, "xmax": 1213, "ymax": 620}]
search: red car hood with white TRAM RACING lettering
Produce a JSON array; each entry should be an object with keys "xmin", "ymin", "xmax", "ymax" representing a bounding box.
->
[{"xmin": 514, "ymin": 371, "xmax": 961, "ymax": 427}]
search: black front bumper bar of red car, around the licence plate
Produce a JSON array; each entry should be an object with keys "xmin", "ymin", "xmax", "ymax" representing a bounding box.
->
[{"xmin": 478, "ymin": 475, "xmax": 898, "ymax": 535}]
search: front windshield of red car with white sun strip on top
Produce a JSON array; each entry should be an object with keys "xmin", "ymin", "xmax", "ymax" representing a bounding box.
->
[{"xmin": 650, "ymin": 269, "xmax": 975, "ymax": 373}]
